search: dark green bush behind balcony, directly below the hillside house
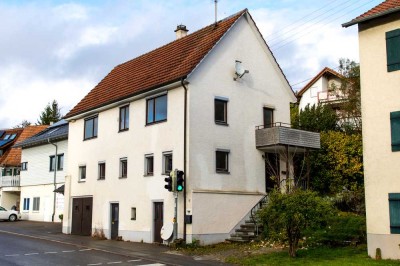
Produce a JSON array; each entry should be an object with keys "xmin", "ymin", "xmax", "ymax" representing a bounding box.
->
[{"xmin": 291, "ymin": 104, "xmax": 338, "ymax": 132}]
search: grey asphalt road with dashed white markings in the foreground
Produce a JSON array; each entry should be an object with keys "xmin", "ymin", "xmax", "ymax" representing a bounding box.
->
[{"xmin": 0, "ymin": 233, "xmax": 165, "ymax": 266}]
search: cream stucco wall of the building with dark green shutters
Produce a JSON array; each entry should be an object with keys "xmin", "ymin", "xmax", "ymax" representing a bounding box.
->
[{"xmin": 359, "ymin": 13, "xmax": 400, "ymax": 259}]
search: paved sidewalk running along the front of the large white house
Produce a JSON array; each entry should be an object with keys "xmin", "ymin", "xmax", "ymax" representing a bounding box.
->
[{"xmin": 0, "ymin": 221, "xmax": 224, "ymax": 265}]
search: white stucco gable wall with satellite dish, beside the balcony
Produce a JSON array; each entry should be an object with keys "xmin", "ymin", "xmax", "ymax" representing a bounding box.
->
[{"xmin": 187, "ymin": 15, "xmax": 295, "ymax": 243}]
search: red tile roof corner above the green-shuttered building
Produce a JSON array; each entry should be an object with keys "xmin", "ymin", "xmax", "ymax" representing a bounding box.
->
[{"xmin": 342, "ymin": 0, "xmax": 400, "ymax": 27}]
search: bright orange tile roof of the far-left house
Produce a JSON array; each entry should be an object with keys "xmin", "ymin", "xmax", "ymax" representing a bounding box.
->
[{"xmin": 0, "ymin": 125, "xmax": 48, "ymax": 166}]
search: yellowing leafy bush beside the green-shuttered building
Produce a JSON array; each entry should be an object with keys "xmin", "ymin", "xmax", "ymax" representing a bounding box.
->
[{"xmin": 310, "ymin": 131, "xmax": 364, "ymax": 195}]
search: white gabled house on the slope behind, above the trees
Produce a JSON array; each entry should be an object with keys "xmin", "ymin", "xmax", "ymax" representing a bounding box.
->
[{"xmin": 296, "ymin": 67, "xmax": 345, "ymax": 110}]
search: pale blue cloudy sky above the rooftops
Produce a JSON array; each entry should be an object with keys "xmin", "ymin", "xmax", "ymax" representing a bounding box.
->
[{"xmin": 0, "ymin": 0, "xmax": 381, "ymax": 129}]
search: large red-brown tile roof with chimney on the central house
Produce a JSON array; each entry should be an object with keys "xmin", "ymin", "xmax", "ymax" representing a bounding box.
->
[{"xmin": 65, "ymin": 9, "xmax": 247, "ymax": 118}]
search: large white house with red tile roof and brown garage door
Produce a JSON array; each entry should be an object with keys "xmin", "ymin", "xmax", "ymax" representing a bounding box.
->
[{"xmin": 63, "ymin": 10, "xmax": 319, "ymax": 244}]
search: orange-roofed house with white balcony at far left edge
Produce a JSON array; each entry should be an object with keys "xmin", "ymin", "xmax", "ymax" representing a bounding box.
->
[{"xmin": 0, "ymin": 126, "xmax": 47, "ymax": 209}]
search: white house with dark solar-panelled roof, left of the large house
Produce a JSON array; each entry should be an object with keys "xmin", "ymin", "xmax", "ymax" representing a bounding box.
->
[{"xmin": 14, "ymin": 120, "xmax": 68, "ymax": 222}]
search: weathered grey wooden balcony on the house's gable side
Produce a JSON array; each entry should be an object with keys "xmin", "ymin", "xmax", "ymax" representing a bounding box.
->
[{"xmin": 256, "ymin": 123, "xmax": 321, "ymax": 152}]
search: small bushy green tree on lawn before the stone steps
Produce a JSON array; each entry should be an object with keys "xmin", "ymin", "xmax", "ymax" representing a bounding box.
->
[{"xmin": 259, "ymin": 190, "xmax": 334, "ymax": 257}]
